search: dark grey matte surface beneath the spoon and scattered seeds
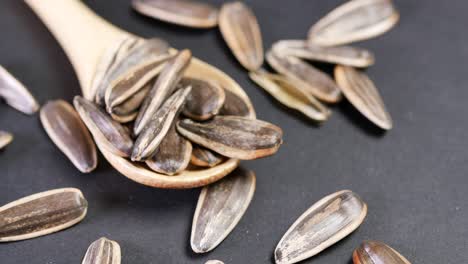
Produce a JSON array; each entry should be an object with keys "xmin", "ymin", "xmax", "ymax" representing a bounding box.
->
[{"xmin": 0, "ymin": 0, "xmax": 468, "ymax": 264}]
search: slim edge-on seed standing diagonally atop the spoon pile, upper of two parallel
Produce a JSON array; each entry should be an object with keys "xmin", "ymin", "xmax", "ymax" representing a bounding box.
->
[{"xmin": 133, "ymin": 50, "xmax": 192, "ymax": 135}]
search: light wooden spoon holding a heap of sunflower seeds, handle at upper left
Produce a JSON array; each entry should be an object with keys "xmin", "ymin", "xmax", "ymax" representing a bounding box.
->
[{"xmin": 25, "ymin": 0, "xmax": 255, "ymax": 189}]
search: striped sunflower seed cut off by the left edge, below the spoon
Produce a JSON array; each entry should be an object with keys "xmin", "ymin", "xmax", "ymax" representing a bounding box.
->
[{"xmin": 0, "ymin": 188, "xmax": 88, "ymax": 242}]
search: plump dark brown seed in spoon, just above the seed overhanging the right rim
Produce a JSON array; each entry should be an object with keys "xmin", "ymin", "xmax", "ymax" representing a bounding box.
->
[{"xmin": 180, "ymin": 78, "xmax": 226, "ymax": 121}]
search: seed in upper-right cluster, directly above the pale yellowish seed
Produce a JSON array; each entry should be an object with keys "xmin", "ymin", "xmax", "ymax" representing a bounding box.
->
[{"xmin": 267, "ymin": 51, "xmax": 341, "ymax": 103}]
